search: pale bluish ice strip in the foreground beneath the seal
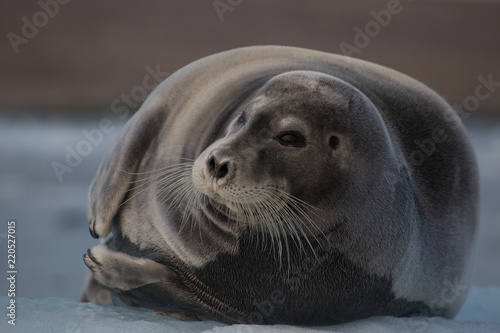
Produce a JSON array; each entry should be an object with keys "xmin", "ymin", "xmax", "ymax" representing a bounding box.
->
[{"xmin": 0, "ymin": 287, "xmax": 500, "ymax": 333}]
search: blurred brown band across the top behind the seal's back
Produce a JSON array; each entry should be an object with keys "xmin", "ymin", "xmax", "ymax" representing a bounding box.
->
[{"xmin": 0, "ymin": 0, "xmax": 500, "ymax": 114}]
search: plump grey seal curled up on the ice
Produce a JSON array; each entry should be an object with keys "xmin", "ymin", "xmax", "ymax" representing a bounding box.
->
[{"xmin": 84, "ymin": 46, "xmax": 478, "ymax": 325}]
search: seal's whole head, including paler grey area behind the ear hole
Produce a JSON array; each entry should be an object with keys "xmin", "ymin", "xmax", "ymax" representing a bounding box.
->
[{"xmin": 192, "ymin": 71, "xmax": 391, "ymax": 243}]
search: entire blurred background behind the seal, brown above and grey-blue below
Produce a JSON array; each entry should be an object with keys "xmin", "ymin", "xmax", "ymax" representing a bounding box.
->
[{"xmin": 0, "ymin": 0, "xmax": 500, "ymax": 299}]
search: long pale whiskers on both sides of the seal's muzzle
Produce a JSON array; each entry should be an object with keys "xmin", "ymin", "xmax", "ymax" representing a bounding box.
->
[{"xmin": 139, "ymin": 162, "xmax": 321, "ymax": 261}]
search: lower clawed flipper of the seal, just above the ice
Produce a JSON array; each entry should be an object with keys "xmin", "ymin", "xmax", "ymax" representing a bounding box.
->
[{"xmin": 83, "ymin": 245, "xmax": 244, "ymax": 323}]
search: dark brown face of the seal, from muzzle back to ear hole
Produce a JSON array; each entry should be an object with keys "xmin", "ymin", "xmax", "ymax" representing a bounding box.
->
[{"xmin": 192, "ymin": 72, "xmax": 356, "ymax": 233}]
